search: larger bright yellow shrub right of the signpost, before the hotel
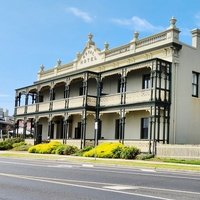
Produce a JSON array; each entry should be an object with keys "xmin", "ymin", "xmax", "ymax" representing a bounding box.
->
[{"xmin": 83, "ymin": 142, "xmax": 124, "ymax": 158}]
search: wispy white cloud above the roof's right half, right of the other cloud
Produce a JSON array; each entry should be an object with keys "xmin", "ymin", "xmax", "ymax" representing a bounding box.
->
[{"xmin": 112, "ymin": 16, "xmax": 163, "ymax": 32}]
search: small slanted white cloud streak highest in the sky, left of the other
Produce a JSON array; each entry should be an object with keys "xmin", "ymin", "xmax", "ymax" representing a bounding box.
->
[{"xmin": 67, "ymin": 7, "xmax": 93, "ymax": 23}]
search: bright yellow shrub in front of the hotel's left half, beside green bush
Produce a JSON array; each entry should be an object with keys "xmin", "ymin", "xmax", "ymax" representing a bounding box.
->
[{"xmin": 28, "ymin": 141, "xmax": 61, "ymax": 154}]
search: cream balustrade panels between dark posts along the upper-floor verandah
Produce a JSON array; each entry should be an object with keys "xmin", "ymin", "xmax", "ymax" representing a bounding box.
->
[{"xmin": 16, "ymin": 90, "xmax": 153, "ymax": 115}]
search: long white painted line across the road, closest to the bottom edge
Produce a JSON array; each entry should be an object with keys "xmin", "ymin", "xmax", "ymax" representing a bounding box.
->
[{"xmin": 0, "ymin": 173, "xmax": 174, "ymax": 200}]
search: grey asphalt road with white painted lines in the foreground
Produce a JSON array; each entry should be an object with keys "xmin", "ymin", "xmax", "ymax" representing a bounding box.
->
[{"xmin": 0, "ymin": 158, "xmax": 200, "ymax": 200}]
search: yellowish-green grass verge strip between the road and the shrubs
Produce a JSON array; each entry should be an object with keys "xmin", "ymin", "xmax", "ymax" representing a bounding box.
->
[{"xmin": 0, "ymin": 151, "xmax": 200, "ymax": 172}]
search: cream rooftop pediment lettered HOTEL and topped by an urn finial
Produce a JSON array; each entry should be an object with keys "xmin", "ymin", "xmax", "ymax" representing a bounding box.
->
[{"xmin": 77, "ymin": 34, "xmax": 102, "ymax": 68}]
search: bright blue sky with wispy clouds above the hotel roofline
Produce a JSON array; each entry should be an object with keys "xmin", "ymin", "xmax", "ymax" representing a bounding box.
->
[{"xmin": 0, "ymin": 0, "xmax": 200, "ymax": 114}]
